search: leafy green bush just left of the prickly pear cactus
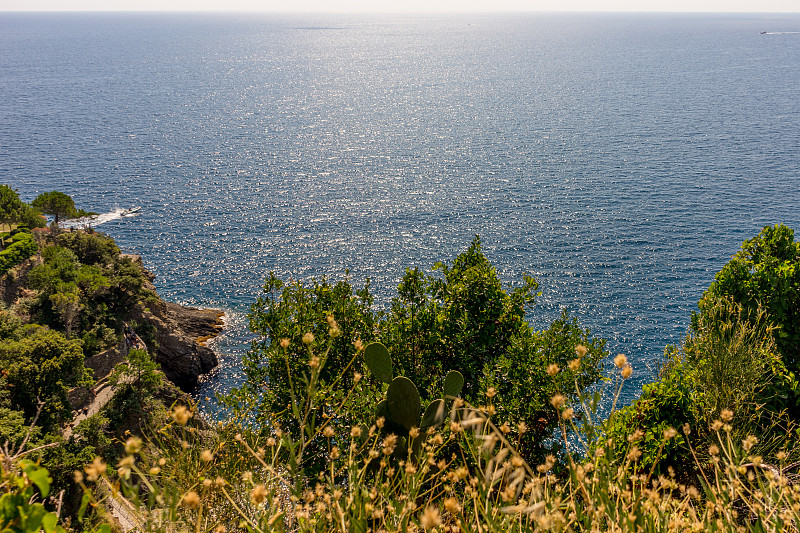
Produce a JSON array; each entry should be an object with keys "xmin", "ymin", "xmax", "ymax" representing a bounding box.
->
[{"xmin": 230, "ymin": 274, "xmax": 377, "ymax": 434}]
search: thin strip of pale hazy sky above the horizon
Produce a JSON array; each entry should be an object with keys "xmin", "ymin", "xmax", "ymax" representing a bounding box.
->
[{"xmin": 0, "ymin": 0, "xmax": 800, "ymax": 13}]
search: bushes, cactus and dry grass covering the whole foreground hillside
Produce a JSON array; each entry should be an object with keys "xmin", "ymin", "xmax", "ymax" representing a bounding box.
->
[{"xmin": 0, "ymin": 186, "xmax": 800, "ymax": 532}]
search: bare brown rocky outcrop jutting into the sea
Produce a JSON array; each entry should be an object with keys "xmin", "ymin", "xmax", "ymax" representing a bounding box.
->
[{"xmin": 126, "ymin": 256, "xmax": 223, "ymax": 392}]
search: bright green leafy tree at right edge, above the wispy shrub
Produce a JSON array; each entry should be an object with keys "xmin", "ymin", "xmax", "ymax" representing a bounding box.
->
[{"xmin": 692, "ymin": 224, "xmax": 800, "ymax": 375}]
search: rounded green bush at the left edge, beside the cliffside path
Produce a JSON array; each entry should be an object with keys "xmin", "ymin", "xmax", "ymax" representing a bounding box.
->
[{"xmin": 0, "ymin": 318, "xmax": 92, "ymax": 431}]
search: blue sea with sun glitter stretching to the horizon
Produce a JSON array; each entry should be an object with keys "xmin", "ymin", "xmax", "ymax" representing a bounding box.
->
[{"xmin": 0, "ymin": 13, "xmax": 800, "ymax": 411}]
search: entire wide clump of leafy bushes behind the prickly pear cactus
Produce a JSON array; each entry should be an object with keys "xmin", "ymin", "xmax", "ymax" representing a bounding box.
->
[{"xmin": 231, "ymin": 238, "xmax": 607, "ymax": 468}]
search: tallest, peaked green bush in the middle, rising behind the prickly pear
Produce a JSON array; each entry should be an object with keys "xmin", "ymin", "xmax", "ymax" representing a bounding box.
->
[{"xmin": 381, "ymin": 237, "xmax": 538, "ymax": 400}]
